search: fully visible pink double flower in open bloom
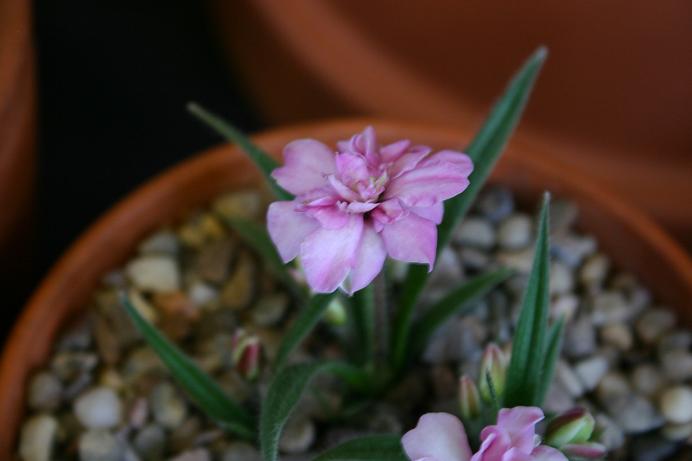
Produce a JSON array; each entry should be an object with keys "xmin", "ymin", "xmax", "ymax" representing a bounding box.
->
[{"xmin": 267, "ymin": 127, "xmax": 473, "ymax": 293}]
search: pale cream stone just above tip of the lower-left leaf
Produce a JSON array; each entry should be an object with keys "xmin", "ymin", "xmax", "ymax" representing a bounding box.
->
[{"xmin": 126, "ymin": 255, "xmax": 180, "ymax": 293}]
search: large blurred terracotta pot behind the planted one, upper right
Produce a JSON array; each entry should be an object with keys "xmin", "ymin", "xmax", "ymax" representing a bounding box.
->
[{"xmin": 211, "ymin": 0, "xmax": 692, "ymax": 244}]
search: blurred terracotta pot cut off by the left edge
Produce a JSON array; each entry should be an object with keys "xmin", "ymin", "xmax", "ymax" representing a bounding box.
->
[{"xmin": 0, "ymin": 0, "xmax": 35, "ymax": 276}]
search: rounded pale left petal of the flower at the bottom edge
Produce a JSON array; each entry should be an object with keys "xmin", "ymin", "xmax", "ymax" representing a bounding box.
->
[{"xmin": 401, "ymin": 413, "xmax": 471, "ymax": 461}]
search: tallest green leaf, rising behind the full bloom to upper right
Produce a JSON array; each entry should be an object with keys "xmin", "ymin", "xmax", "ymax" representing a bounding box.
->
[{"xmin": 392, "ymin": 47, "xmax": 547, "ymax": 368}]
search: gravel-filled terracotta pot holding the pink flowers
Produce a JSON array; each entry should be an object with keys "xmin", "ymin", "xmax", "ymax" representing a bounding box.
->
[{"xmin": 0, "ymin": 119, "xmax": 692, "ymax": 459}]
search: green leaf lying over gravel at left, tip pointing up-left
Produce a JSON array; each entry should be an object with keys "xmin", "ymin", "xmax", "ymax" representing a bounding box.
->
[{"xmin": 121, "ymin": 295, "xmax": 256, "ymax": 439}]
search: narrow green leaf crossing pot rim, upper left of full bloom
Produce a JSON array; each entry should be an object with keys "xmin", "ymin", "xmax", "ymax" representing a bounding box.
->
[{"xmin": 187, "ymin": 102, "xmax": 293, "ymax": 200}]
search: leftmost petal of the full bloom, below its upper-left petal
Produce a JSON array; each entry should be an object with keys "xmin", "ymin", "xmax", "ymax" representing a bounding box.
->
[{"xmin": 267, "ymin": 202, "xmax": 319, "ymax": 262}]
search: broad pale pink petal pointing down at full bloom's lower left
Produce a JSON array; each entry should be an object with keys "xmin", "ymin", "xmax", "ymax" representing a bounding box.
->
[{"xmin": 300, "ymin": 215, "xmax": 363, "ymax": 293}]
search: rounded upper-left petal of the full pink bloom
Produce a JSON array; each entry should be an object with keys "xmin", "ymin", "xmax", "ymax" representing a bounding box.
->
[{"xmin": 272, "ymin": 139, "xmax": 336, "ymax": 195}]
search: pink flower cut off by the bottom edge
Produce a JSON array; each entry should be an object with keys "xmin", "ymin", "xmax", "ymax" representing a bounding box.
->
[{"xmin": 401, "ymin": 407, "xmax": 567, "ymax": 461}]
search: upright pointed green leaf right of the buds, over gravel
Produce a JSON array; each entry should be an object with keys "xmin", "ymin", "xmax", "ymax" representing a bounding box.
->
[{"xmin": 504, "ymin": 193, "xmax": 550, "ymax": 407}]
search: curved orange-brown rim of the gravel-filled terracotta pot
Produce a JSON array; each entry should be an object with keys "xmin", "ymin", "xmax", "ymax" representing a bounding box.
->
[{"xmin": 0, "ymin": 118, "xmax": 692, "ymax": 455}]
